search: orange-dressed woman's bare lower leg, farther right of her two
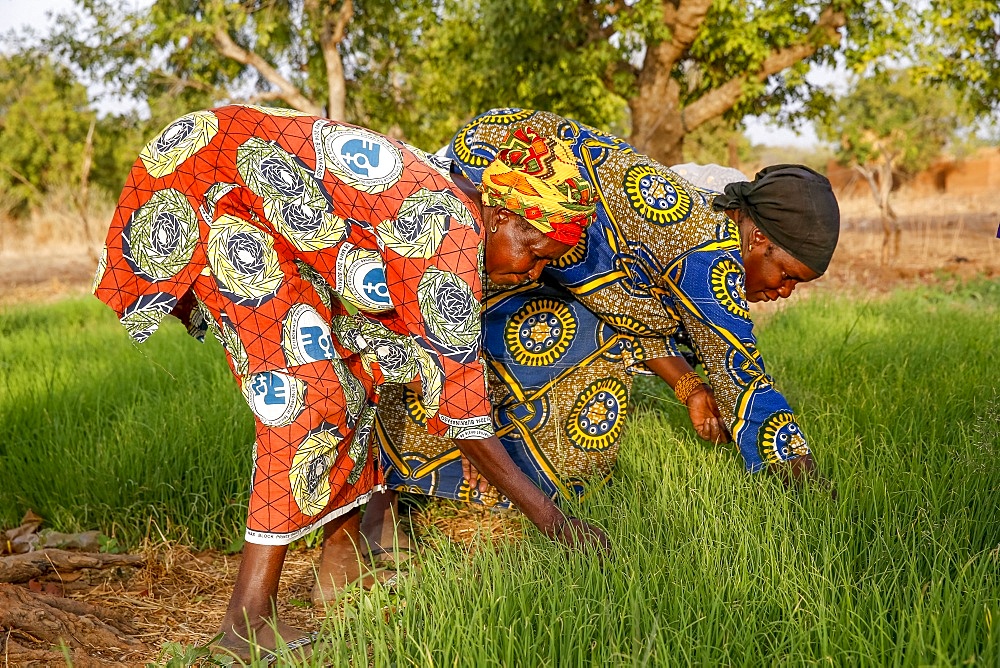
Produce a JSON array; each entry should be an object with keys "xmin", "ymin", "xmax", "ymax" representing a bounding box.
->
[{"xmin": 312, "ymin": 508, "xmax": 383, "ymax": 605}]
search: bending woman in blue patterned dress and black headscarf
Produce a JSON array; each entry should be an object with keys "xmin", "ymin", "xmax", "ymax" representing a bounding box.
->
[{"xmin": 366, "ymin": 109, "xmax": 840, "ymax": 552}]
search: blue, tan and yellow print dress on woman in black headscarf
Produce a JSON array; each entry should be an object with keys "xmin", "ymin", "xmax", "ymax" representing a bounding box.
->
[{"xmin": 379, "ymin": 109, "xmax": 809, "ymax": 500}]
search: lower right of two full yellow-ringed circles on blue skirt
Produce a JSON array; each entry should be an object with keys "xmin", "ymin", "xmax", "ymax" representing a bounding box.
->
[{"xmin": 566, "ymin": 377, "xmax": 628, "ymax": 451}]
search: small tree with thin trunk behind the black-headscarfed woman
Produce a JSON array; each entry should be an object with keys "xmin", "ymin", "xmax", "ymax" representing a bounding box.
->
[{"xmin": 818, "ymin": 69, "xmax": 971, "ymax": 260}]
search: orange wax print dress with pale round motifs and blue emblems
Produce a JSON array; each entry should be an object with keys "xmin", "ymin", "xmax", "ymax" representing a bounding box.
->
[{"xmin": 95, "ymin": 106, "xmax": 493, "ymax": 544}]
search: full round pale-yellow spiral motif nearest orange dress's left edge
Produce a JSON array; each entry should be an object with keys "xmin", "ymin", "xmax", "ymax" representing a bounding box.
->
[{"xmin": 122, "ymin": 188, "xmax": 198, "ymax": 281}]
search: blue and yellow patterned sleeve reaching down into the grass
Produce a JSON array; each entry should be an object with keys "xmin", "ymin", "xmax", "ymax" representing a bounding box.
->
[{"xmin": 664, "ymin": 240, "xmax": 809, "ymax": 472}]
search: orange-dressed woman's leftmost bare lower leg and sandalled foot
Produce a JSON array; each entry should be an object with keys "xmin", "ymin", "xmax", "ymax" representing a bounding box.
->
[{"xmin": 219, "ymin": 543, "xmax": 305, "ymax": 659}]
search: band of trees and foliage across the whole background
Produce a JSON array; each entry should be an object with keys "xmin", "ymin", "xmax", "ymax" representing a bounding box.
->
[{"xmin": 0, "ymin": 0, "xmax": 1000, "ymax": 222}]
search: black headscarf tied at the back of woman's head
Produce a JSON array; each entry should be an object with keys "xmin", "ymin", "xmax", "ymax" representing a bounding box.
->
[{"xmin": 712, "ymin": 165, "xmax": 840, "ymax": 274}]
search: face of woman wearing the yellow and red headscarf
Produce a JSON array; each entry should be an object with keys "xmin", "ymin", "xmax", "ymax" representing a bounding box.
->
[{"xmin": 486, "ymin": 209, "xmax": 573, "ymax": 285}]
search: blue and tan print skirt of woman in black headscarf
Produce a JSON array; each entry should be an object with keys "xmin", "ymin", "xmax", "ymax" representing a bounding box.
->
[{"xmin": 376, "ymin": 283, "xmax": 634, "ymax": 507}]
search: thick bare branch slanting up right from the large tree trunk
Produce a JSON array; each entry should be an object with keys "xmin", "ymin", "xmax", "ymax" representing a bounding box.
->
[{"xmin": 681, "ymin": 7, "xmax": 846, "ymax": 131}]
